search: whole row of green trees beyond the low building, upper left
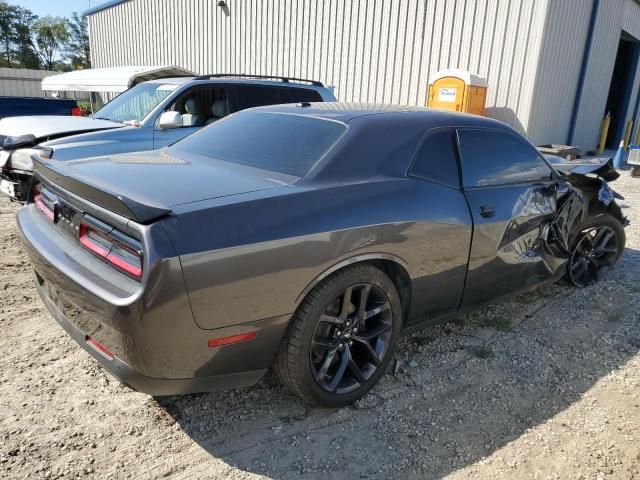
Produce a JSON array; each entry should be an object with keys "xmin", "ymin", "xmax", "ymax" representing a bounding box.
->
[{"xmin": 0, "ymin": 0, "xmax": 91, "ymax": 71}]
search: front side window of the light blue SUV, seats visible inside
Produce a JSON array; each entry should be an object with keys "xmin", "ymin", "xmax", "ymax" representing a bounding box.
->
[{"xmin": 165, "ymin": 87, "xmax": 229, "ymax": 127}]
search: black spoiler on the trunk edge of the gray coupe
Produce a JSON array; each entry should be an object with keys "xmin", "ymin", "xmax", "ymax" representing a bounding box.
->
[{"xmin": 32, "ymin": 155, "xmax": 171, "ymax": 223}]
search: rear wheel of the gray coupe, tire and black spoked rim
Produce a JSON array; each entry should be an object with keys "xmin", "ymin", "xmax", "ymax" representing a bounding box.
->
[{"xmin": 273, "ymin": 264, "xmax": 402, "ymax": 408}]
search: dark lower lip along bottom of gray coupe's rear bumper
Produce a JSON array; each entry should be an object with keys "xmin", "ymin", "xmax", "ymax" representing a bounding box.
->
[{"xmin": 36, "ymin": 281, "xmax": 267, "ymax": 396}]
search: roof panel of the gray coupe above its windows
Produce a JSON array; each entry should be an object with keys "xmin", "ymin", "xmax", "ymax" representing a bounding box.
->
[{"xmin": 251, "ymin": 102, "xmax": 511, "ymax": 130}]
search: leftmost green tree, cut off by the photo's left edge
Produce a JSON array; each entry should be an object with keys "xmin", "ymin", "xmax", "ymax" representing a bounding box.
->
[{"xmin": 0, "ymin": 1, "xmax": 40, "ymax": 68}]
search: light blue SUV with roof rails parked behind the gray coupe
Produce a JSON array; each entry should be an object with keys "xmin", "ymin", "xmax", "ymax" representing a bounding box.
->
[{"xmin": 0, "ymin": 74, "xmax": 335, "ymax": 201}]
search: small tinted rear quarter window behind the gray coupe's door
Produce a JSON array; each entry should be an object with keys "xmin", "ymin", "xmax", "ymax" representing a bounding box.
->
[{"xmin": 411, "ymin": 128, "xmax": 460, "ymax": 187}]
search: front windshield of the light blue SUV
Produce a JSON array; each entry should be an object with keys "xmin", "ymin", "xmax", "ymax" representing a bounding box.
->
[{"xmin": 93, "ymin": 83, "xmax": 178, "ymax": 122}]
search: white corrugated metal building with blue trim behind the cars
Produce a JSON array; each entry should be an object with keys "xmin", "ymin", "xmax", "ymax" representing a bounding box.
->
[{"xmin": 88, "ymin": 0, "xmax": 640, "ymax": 150}]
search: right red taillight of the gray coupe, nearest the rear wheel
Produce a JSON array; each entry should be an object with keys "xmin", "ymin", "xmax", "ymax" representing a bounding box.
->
[{"xmin": 79, "ymin": 220, "xmax": 142, "ymax": 279}]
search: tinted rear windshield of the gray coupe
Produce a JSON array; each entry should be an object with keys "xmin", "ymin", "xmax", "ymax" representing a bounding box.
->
[{"xmin": 170, "ymin": 112, "xmax": 346, "ymax": 177}]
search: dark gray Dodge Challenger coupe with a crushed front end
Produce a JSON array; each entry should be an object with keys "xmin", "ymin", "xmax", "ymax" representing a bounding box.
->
[{"xmin": 18, "ymin": 103, "xmax": 627, "ymax": 407}]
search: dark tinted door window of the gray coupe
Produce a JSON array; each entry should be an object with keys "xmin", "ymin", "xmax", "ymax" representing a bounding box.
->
[{"xmin": 459, "ymin": 129, "xmax": 551, "ymax": 187}]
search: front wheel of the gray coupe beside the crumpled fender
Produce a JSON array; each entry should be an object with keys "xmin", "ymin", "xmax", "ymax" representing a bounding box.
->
[{"xmin": 564, "ymin": 213, "xmax": 626, "ymax": 288}]
